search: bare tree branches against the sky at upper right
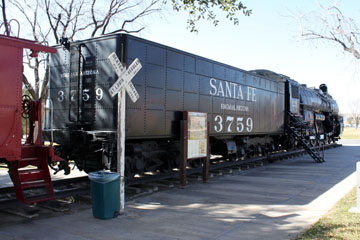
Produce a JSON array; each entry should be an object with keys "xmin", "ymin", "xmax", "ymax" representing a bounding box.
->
[{"xmin": 296, "ymin": 5, "xmax": 360, "ymax": 59}]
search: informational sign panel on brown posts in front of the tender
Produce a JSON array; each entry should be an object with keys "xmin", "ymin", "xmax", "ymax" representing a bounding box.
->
[{"xmin": 187, "ymin": 112, "xmax": 208, "ymax": 159}]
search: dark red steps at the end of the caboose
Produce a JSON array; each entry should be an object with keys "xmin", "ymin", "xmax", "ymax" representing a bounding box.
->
[{"xmin": 9, "ymin": 145, "xmax": 54, "ymax": 204}]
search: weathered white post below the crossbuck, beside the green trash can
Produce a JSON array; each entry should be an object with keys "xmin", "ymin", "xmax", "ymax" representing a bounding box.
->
[{"xmin": 117, "ymin": 88, "xmax": 126, "ymax": 214}]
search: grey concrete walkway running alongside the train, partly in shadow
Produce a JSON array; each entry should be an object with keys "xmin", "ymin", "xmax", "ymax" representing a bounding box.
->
[{"xmin": 0, "ymin": 142, "xmax": 360, "ymax": 240}]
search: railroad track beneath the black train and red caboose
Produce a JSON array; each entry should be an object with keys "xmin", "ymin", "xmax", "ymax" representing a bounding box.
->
[{"xmin": 0, "ymin": 144, "xmax": 341, "ymax": 218}]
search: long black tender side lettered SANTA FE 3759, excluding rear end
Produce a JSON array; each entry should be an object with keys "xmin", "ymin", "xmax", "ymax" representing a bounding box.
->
[{"xmin": 126, "ymin": 37, "xmax": 285, "ymax": 138}]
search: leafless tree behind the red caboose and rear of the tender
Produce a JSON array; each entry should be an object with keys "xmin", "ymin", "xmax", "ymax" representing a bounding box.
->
[{"xmin": 2, "ymin": 0, "xmax": 162, "ymax": 99}]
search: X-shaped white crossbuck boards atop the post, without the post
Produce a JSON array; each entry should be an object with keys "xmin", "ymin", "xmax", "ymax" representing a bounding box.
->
[{"xmin": 108, "ymin": 52, "xmax": 142, "ymax": 102}]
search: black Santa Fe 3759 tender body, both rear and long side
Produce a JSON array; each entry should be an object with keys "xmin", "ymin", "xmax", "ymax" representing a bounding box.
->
[{"xmin": 48, "ymin": 35, "xmax": 285, "ymax": 141}]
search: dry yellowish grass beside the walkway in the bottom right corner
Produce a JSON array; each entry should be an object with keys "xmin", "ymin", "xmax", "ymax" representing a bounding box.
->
[{"xmin": 297, "ymin": 188, "xmax": 360, "ymax": 240}]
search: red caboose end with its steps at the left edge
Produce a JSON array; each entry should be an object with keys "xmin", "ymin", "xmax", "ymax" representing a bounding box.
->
[{"xmin": 0, "ymin": 35, "xmax": 56, "ymax": 203}]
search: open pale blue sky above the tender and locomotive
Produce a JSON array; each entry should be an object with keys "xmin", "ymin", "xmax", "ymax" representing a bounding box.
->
[{"xmin": 139, "ymin": 0, "xmax": 360, "ymax": 112}]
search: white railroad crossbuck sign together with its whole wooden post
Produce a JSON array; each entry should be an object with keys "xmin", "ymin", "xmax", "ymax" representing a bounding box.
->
[{"xmin": 108, "ymin": 52, "xmax": 142, "ymax": 214}]
